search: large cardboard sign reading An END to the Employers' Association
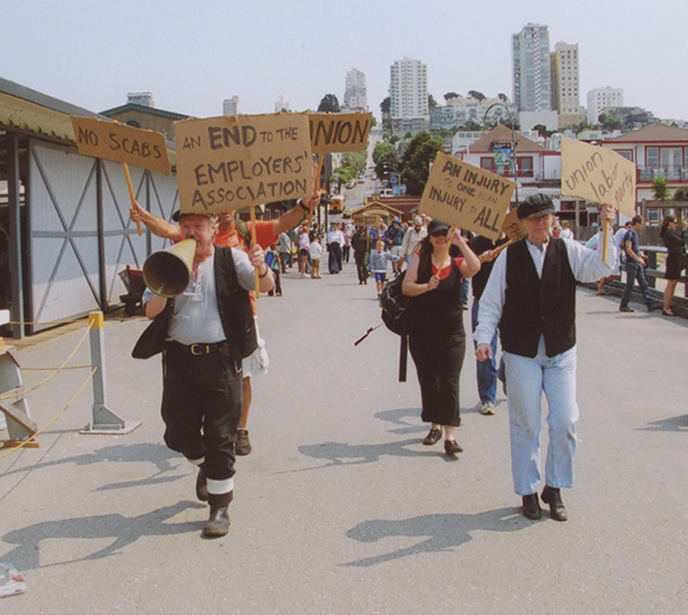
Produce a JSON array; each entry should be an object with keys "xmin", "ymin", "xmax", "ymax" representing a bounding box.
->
[{"xmin": 174, "ymin": 113, "xmax": 313, "ymax": 213}]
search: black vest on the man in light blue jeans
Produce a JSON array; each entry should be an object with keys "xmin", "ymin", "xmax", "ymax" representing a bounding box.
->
[{"xmin": 499, "ymin": 239, "xmax": 576, "ymax": 358}]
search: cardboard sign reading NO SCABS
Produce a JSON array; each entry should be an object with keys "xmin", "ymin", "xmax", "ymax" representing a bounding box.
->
[{"xmin": 72, "ymin": 116, "xmax": 171, "ymax": 175}]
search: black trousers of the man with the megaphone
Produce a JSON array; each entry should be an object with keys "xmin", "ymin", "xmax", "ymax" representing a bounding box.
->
[{"xmin": 162, "ymin": 344, "xmax": 242, "ymax": 488}]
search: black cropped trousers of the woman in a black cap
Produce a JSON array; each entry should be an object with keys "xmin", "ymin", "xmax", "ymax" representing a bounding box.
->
[{"xmin": 409, "ymin": 334, "xmax": 466, "ymax": 427}]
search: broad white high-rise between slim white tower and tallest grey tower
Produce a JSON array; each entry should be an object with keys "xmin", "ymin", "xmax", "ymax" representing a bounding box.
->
[{"xmin": 389, "ymin": 58, "xmax": 430, "ymax": 121}]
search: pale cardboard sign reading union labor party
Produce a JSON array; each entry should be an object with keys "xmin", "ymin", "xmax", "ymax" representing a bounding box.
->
[{"xmin": 561, "ymin": 139, "xmax": 636, "ymax": 217}]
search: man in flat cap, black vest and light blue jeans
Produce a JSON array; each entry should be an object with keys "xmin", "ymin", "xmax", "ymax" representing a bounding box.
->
[{"xmin": 473, "ymin": 194, "xmax": 617, "ymax": 521}]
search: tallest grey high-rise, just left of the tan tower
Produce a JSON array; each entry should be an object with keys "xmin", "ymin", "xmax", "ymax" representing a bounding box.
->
[{"xmin": 511, "ymin": 23, "xmax": 552, "ymax": 111}]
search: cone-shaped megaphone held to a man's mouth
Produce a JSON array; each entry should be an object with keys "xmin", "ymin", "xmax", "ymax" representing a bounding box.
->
[{"xmin": 143, "ymin": 239, "xmax": 196, "ymax": 299}]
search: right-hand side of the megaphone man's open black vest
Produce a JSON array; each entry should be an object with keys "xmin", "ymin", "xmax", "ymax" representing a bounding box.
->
[{"xmin": 213, "ymin": 246, "xmax": 258, "ymax": 360}]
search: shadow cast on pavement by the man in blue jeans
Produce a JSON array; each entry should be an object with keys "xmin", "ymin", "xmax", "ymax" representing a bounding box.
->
[{"xmin": 342, "ymin": 508, "xmax": 533, "ymax": 566}]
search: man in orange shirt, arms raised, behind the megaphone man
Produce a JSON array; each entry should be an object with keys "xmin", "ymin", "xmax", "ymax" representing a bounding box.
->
[{"xmin": 129, "ymin": 193, "xmax": 320, "ymax": 455}]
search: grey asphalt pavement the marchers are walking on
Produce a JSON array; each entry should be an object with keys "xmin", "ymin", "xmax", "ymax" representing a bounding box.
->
[{"xmin": 0, "ymin": 263, "xmax": 688, "ymax": 615}]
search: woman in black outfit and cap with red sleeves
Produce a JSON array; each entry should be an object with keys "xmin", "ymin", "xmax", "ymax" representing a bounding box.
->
[{"xmin": 402, "ymin": 220, "xmax": 480, "ymax": 455}]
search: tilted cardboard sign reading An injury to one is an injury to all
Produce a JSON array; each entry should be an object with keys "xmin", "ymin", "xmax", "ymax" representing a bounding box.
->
[{"xmin": 420, "ymin": 152, "xmax": 516, "ymax": 239}]
